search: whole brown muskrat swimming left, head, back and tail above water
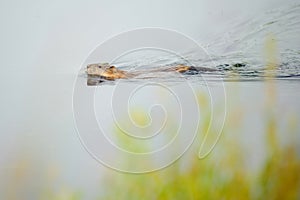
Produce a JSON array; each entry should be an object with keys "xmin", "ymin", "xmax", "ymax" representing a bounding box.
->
[{"xmin": 86, "ymin": 63, "xmax": 217, "ymax": 83}]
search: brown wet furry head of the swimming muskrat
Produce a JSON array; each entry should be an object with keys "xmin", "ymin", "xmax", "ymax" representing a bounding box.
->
[{"xmin": 86, "ymin": 63, "xmax": 125, "ymax": 80}]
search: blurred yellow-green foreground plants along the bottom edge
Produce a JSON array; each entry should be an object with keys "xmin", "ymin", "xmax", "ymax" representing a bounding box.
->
[{"xmin": 2, "ymin": 85, "xmax": 300, "ymax": 200}]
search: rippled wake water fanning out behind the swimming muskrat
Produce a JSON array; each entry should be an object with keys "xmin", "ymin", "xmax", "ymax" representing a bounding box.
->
[{"xmin": 81, "ymin": 5, "xmax": 300, "ymax": 85}]
